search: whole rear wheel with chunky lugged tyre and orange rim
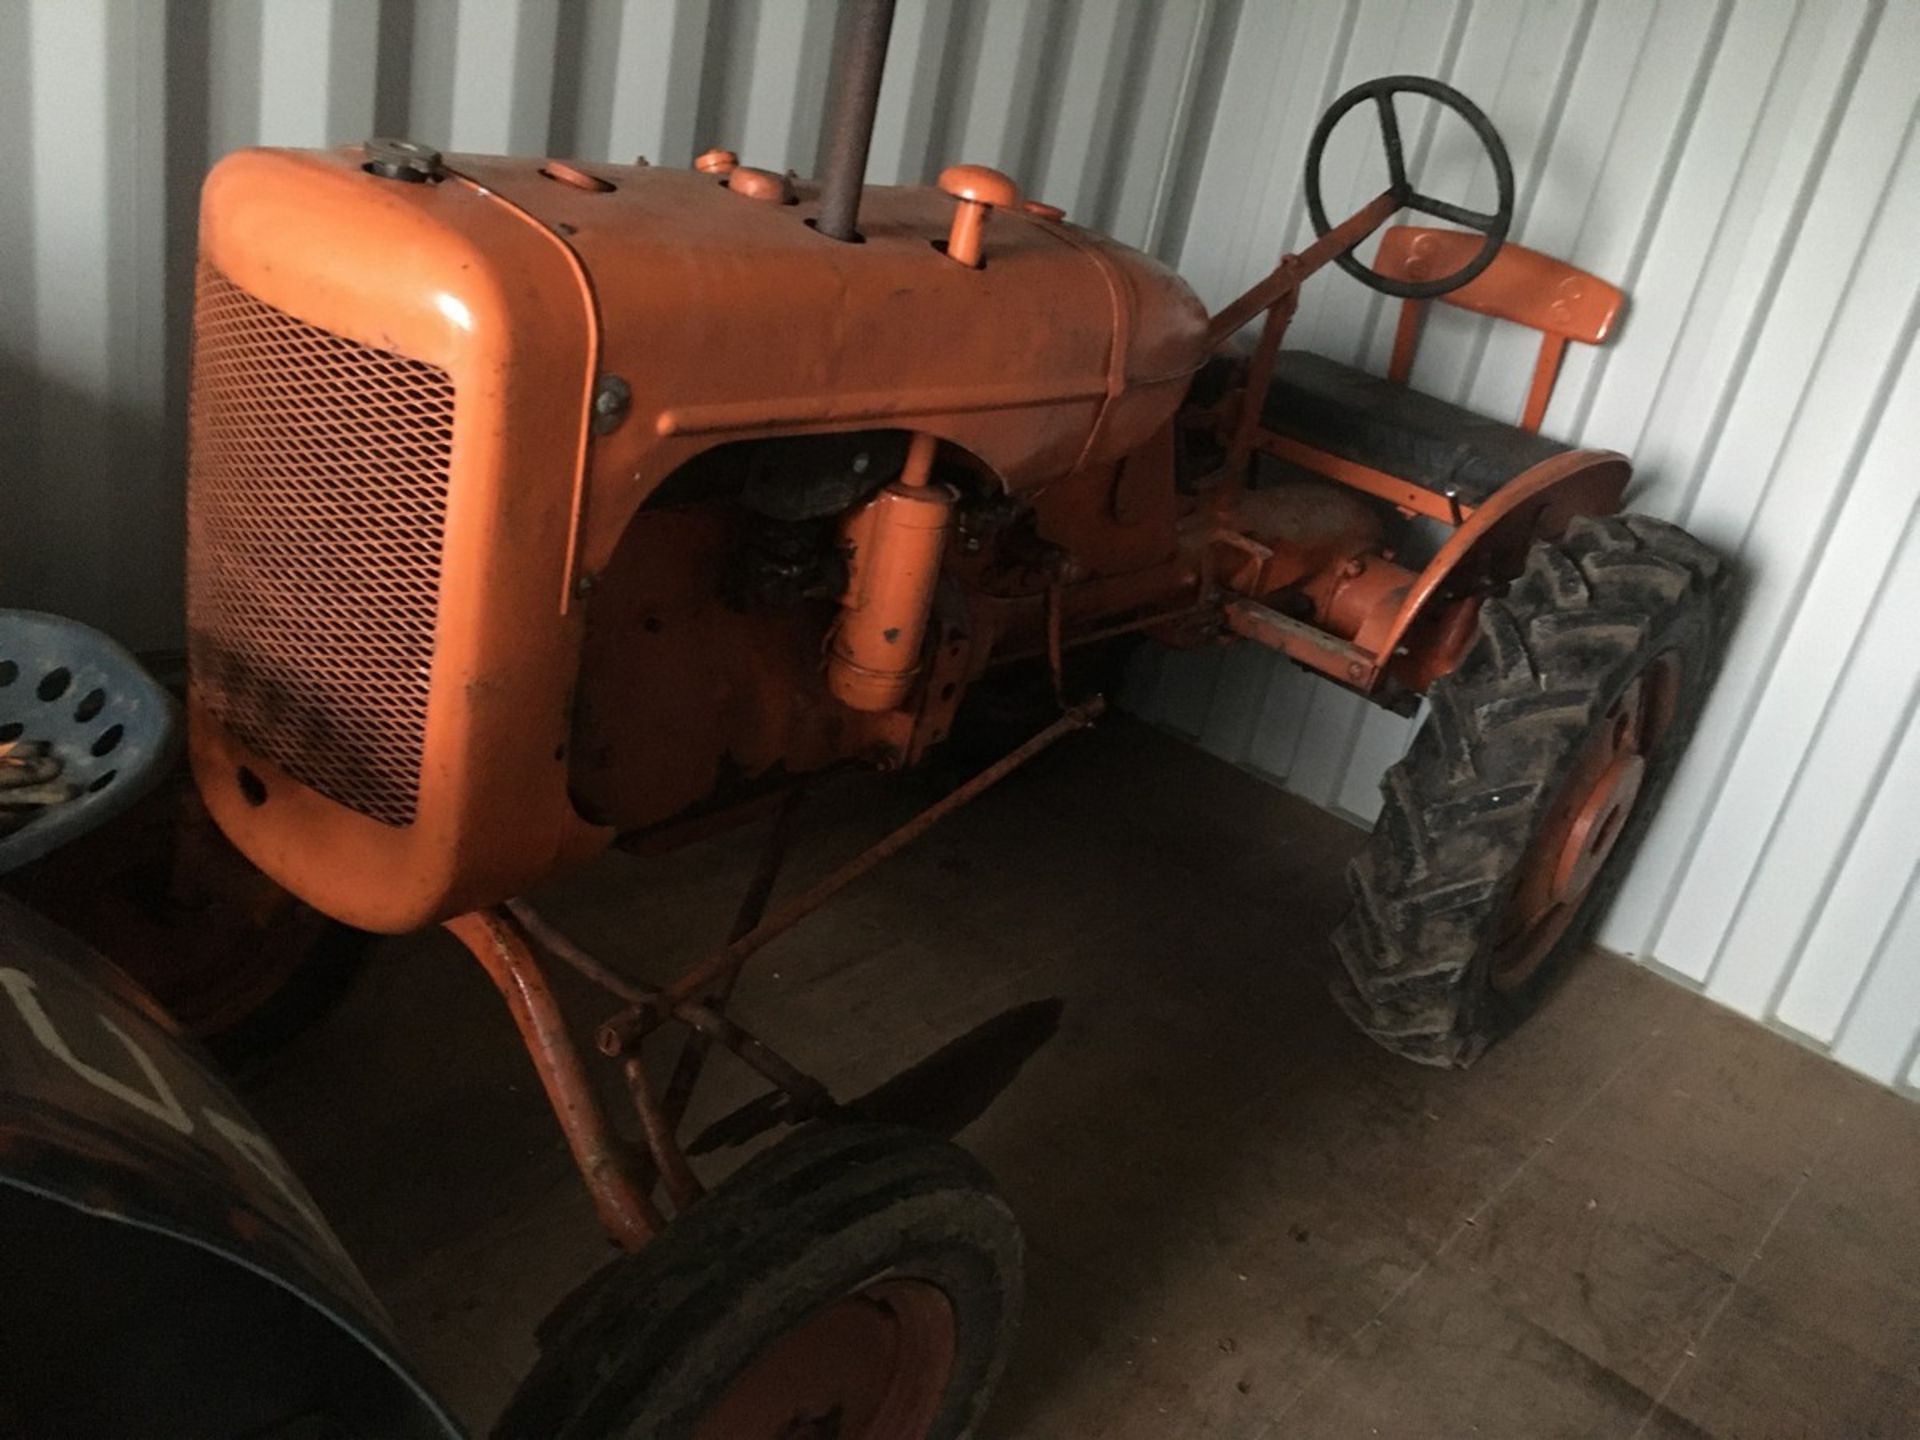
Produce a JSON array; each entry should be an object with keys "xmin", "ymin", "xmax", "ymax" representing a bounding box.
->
[{"xmin": 1334, "ymin": 515, "xmax": 1722, "ymax": 1066}]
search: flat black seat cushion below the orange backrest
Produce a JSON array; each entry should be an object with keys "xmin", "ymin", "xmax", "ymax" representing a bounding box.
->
[{"xmin": 1260, "ymin": 349, "xmax": 1571, "ymax": 507}]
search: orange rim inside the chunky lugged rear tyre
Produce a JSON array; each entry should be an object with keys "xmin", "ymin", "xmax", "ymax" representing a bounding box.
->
[{"xmin": 1492, "ymin": 651, "xmax": 1680, "ymax": 991}]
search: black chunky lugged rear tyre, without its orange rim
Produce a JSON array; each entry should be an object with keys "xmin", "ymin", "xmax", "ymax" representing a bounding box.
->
[{"xmin": 1332, "ymin": 515, "xmax": 1726, "ymax": 1066}]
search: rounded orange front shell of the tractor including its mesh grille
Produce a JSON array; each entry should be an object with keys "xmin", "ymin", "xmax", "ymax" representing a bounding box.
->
[{"xmin": 186, "ymin": 150, "xmax": 599, "ymax": 931}]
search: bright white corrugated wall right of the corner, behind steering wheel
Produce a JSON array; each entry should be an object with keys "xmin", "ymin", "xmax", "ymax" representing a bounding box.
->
[{"xmin": 1139, "ymin": 0, "xmax": 1920, "ymax": 1087}]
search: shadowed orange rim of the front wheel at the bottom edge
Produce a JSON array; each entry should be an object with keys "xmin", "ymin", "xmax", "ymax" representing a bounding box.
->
[{"xmin": 693, "ymin": 1279, "xmax": 956, "ymax": 1440}]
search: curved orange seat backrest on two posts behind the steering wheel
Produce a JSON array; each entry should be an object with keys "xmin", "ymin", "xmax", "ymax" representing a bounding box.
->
[{"xmin": 1373, "ymin": 225, "xmax": 1626, "ymax": 430}]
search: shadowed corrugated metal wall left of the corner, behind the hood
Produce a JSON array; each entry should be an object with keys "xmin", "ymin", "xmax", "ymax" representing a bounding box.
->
[{"xmin": 0, "ymin": 0, "xmax": 1235, "ymax": 645}]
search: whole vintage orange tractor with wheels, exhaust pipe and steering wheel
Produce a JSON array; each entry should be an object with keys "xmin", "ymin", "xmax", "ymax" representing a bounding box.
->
[{"xmin": 188, "ymin": 0, "xmax": 1718, "ymax": 1440}]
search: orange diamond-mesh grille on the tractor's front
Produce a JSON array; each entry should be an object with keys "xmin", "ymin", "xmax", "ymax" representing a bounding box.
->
[{"xmin": 186, "ymin": 265, "xmax": 453, "ymax": 826}]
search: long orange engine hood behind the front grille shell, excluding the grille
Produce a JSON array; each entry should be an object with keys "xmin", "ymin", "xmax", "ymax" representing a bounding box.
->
[{"xmin": 445, "ymin": 156, "xmax": 1206, "ymax": 564}]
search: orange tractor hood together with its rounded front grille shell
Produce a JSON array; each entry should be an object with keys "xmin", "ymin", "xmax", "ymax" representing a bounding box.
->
[{"xmin": 188, "ymin": 146, "xmax": 1206, "ymax": 931}]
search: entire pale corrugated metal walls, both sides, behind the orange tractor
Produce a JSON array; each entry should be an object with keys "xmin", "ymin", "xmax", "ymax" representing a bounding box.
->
[{"xmin": 0, "ymin": 0, "xmax": 1920, "ymax": 1085}]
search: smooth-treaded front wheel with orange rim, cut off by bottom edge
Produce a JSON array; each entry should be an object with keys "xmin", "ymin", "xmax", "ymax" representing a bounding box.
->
[{"xmin": 493, "ymin": 1125, "xmax": 1021, "ymax": 1440}]
